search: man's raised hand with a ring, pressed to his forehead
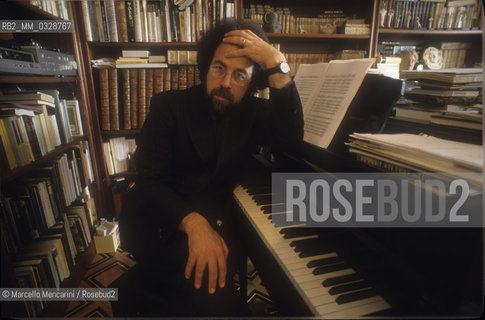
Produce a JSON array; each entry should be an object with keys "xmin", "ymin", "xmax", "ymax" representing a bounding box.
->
[{"xmin": 222, "ymin": 30, "xmax": 291, "ymax": 88}]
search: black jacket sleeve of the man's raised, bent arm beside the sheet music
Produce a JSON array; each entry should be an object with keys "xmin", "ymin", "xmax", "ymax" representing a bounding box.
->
[{"xmin": 254, "ymin": 81, "xmax": 303, "ymax": 151}]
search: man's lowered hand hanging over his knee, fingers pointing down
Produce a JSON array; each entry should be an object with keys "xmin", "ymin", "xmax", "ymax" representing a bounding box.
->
[{"xmin": 179, "ymin": 212, "xmax": 229, "ymax": 293}]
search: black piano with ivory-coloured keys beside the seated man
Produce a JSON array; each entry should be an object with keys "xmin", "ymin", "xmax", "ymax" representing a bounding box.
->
[{"xmin": 233, "ymin": 77, "xmax": 484, "ymax": 319}]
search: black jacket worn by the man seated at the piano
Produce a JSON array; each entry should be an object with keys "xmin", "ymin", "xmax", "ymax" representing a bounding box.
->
[{"xmin": 120, "ymin": 82, "xmax": 303, "ymax": 263}]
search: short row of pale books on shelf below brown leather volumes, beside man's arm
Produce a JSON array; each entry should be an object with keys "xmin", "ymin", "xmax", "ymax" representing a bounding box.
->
[{"xmin": 103, "ymin": 137, "xmax": 136, "ymax": 175}]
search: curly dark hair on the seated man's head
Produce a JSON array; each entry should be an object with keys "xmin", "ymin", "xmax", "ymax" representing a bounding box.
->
[{"xmin": 197, "ymin": 19, "xmax": 269, "ymax": 93}]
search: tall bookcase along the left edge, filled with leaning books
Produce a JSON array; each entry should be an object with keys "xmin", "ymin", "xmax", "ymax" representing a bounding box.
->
[{"xmin": 0, "ymin": 1, "xmax": 101, "ymax": 318}]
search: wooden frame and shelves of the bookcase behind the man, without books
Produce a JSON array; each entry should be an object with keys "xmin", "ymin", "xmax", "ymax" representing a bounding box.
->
[{"xmin": 74, "ymin": 0, "xmax": 482, "ymax": 218}]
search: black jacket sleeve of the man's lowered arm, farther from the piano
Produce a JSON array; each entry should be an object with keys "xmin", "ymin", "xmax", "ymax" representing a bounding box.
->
[{"xmin": 131, "ymin": 94, "xmax": 192, "ymax": 235}]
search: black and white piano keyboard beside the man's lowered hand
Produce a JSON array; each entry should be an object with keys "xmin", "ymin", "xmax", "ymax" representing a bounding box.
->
[{"xmin": 234, "ymin": 186, "xmax": 391, "ymax": 319}]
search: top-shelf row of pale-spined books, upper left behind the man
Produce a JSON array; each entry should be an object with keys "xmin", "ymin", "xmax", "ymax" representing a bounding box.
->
[{"xmin": 82, "ymin": 0, "xmax": 234, "ymax": 42}]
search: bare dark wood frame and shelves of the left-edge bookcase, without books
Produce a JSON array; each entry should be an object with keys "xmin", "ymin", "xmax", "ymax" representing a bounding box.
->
[{"xmin": 0, "ymin": 1, "xmax": 99, "ymax": 317}]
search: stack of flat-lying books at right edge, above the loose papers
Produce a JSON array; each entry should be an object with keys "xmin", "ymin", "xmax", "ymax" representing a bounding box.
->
[{"xmin": 395, "ymin": 68, "xmax": 483, "ymax": 130}]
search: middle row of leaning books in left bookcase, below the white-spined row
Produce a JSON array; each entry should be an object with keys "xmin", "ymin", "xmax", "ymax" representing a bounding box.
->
[{"xmin": 1, "ymin": 146, "xmax": 94, "ymax": 255}]
